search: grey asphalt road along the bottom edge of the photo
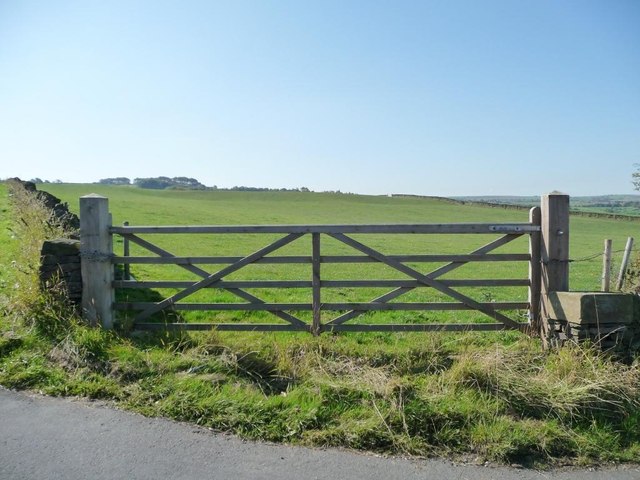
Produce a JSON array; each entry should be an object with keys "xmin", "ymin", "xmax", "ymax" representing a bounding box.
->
[{"xmin": 0, "ymin": 387, "xmax": 640, "ymax": 480}]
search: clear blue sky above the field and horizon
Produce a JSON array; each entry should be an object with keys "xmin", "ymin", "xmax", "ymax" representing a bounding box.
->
[{"xmin": 0, "ymin": 0, "xmax": 640, "ymax": 195}]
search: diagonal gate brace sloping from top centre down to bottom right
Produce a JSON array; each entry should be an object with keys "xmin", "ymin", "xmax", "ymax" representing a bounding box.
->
[{"xmin": 328, "ymin": 233, "xmax": 521, "ymax": 329}]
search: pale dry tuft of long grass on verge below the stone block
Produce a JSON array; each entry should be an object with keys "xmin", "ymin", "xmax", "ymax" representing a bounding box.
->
[{"xmin": 455, "ymin": 344, "xmax": 640, "ymax": 422}]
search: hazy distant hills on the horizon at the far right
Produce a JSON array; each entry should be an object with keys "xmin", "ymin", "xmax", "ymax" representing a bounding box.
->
[{"xmin": 451, "ymin": 195, "xmax": 640, "ymax": 216}]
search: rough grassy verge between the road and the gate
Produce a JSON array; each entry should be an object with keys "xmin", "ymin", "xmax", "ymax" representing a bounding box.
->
[{"xmin": 0, "ymin": 185, "xmax": 640, "ymax": 465}]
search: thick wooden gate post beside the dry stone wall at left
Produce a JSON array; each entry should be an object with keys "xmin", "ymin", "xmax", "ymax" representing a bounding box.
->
[{"xmin": 80, "ymin": 194, "xmax": 114, "ymax": 329}]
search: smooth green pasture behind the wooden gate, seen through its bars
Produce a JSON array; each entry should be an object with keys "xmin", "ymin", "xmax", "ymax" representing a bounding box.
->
[{"xmin": 44, "ymin": 184, "xmax": 640, "ymax": 323}]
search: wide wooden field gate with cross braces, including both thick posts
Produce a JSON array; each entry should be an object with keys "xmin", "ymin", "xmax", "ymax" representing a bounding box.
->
[{"xmin": 80, "ymin": 193, "xmax": 569, "ymax": 335}]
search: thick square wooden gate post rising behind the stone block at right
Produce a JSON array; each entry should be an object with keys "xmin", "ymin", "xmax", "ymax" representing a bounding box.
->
[{"xmin": 541, "ymin": 192, "xmax": 569, "ymax": 295}]
